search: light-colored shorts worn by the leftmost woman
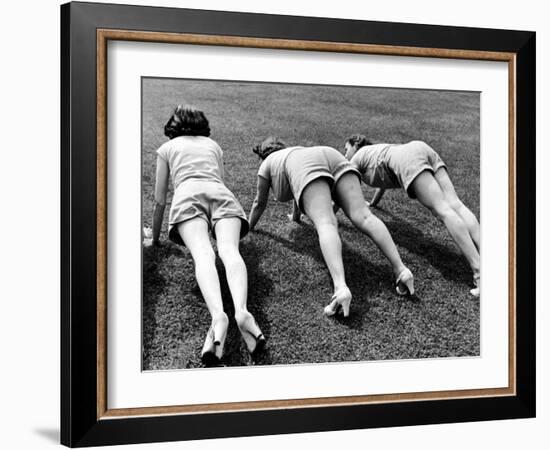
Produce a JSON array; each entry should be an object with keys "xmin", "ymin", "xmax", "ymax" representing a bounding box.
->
[{"xmin": 168, "ymin": 180, "xmax": 249, "ymax": 245}]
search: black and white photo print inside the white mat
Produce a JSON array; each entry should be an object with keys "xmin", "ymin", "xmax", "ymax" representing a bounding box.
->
[{"xmin": 141, "ymin": 77, "xmax": 481, "ymax": 370}]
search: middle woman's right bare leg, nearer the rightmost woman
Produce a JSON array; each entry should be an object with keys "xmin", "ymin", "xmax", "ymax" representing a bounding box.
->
[{"xmin": 335, "ymin": 173, "xmax": 405, "ymax": 277}]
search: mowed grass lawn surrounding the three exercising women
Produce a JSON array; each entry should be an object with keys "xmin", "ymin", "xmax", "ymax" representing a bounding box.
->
[{"xmin": 142, "ymin": 79, "xmax": 480, "ymax": 370}]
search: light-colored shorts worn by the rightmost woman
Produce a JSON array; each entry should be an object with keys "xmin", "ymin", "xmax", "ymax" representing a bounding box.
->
[{"xmin": 388, "ymin": 141, "xmax": 447, "ymax": 198}]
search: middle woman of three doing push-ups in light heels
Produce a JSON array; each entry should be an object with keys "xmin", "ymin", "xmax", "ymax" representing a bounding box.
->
[{"xmin": 250, "ymin": 137, "xmax": 414, "ymax": 316}]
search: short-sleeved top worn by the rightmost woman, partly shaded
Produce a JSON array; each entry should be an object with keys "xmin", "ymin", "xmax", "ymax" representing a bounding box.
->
[{"xmin": 351, "ymin": 144, "xmax": 401, "ymax": 189}]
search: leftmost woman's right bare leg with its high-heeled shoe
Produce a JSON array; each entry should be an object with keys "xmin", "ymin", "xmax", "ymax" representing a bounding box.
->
[{"xmin": 216, "ymin": 217, "xmax": 263, "ymax": 352}]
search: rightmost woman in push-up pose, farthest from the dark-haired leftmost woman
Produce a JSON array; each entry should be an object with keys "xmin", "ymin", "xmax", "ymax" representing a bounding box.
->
[{"xmin": 345, "ymin": 134, "xmax": 480, "ymax": 297}]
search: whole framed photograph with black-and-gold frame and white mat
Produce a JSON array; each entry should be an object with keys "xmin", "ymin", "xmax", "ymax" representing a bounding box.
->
[{"xmin": 61, "ymin": 3, "xmax": 535, "ymax": 447}]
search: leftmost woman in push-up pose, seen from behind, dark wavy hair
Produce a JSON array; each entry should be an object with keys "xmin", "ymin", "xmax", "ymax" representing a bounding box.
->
[{"xmin": 147, "ymin": 105, "xmax": 265, "ymax": 366}]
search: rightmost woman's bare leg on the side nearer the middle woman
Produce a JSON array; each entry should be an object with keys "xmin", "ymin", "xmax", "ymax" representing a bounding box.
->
[{"xmin": 413, "ymin": 171, "xmax": 479, "ymax": 278}]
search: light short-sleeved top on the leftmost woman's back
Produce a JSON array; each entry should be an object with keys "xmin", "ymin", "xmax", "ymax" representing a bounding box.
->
[{"xmin": 157, "ymin": 136, "xmax": 223, "ymax": 189}]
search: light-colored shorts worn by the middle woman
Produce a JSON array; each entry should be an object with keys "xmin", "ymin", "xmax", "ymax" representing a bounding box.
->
[{"xmin": 285, "ymin": 146, "xmax": 361, "ymax": 213}]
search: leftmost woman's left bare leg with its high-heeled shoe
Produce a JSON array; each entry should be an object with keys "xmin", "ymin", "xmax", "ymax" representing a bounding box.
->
[{"xmin": 178, "ymin": 217, "xmax": 229, "ymax": 358}]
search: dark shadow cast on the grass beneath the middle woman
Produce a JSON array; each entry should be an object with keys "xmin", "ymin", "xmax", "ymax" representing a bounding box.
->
[{"xmin": 256, "ymin": 223, "xmax": 393, "ymax": 329}]
